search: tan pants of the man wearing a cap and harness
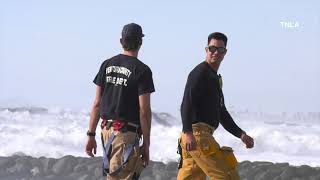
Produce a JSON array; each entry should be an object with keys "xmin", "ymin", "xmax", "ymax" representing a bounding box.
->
[{"xmin": 101, "ymin": 127, "xmax": 143, "ymax": 180}]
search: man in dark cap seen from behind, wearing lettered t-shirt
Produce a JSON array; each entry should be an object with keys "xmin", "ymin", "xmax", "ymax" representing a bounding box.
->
[{"xmin": 86, "ymin": 23, "xmax": 155, "ymax": 180}]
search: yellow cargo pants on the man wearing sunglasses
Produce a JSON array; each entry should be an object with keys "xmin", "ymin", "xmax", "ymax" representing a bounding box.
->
[{"xmin": 177, "ymin": 123, "xmax": 240, "ymax": 180}]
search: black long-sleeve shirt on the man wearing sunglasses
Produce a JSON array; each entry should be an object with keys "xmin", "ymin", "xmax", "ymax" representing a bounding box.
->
[{"xmin": 181, "ymin": 62, "xmax": 243, "ymax": 138}]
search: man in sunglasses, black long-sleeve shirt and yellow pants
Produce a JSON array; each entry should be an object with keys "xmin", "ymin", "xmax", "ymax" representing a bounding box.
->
[{"xmin": 178, "ymin": 32, "xmax": 254, "ymax": 180}]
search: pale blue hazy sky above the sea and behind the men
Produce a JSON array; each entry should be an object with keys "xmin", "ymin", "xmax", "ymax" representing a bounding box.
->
[{"xmin": 0, "ymin": 0, "xmax": 320, "ymax": 116}]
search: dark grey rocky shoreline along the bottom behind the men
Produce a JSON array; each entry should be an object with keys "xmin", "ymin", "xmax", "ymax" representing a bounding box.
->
[{"xmin": 0, "ymin": 155, "xmax": 320, "ymax": 180}]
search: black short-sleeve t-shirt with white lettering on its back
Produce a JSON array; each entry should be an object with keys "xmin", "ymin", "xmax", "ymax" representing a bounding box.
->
[{"xmin": 93, "ymin": 54, "xmax": 155, "ymax": 124}]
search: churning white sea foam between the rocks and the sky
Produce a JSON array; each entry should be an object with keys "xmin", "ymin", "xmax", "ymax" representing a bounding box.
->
[{"xmin": 0, "ymin": 108, "xmax": 320, "ymax": 166}]
